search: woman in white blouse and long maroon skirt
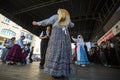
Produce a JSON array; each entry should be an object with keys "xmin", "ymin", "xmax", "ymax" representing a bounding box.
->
[{"xmin": 7, "ymin": 35, "xmax": 25, "ymax": 65}]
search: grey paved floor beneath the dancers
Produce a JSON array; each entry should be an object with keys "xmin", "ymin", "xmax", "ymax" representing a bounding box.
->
[{"xmin": 0, "ymin": 62, "xmax": 120, "ymax": 80}]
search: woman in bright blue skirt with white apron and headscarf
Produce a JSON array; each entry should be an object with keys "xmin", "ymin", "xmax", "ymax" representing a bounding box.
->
[{"xmin": 72, "ymin": 35, "xmax": 89, "ymax": 67}]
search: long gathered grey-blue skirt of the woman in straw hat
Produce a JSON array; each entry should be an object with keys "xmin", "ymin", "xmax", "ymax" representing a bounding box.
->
[{"xmin": 44, "ymin": 28, "xmax": 74, "ymax": 77}]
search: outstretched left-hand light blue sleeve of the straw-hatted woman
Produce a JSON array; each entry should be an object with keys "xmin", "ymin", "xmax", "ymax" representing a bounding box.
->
[{"xmin": 38, "ymin": 15, "xmax": 57, "ymax": 26}]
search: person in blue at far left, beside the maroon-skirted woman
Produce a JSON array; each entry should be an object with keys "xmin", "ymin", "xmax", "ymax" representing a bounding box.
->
[{"xmin": 1, "ymin": 37, "xmax": 15, "ymax": 62}]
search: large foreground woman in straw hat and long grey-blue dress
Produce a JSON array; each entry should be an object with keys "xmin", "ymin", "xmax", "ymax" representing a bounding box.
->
[{"xmin": 33, "ymin": 9, "xmax": 74, "ymax": 78}]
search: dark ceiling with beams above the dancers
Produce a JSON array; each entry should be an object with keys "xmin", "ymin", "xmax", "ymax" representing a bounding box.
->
[{"xmin": 0, "ymin": 0, "xmax": 120, "ymax": 41}]
